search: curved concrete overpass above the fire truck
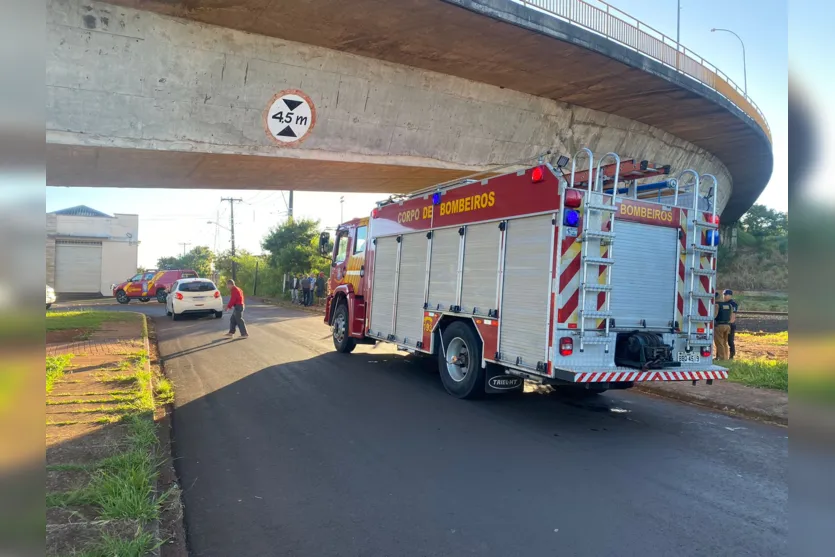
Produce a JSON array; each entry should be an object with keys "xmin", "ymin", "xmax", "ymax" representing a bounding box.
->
[{"xmin": 46, "ymin": 0, "xmax": 772, "ymax": 220}]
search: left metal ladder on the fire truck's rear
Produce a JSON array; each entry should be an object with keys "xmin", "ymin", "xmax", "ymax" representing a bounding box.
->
[{"xmin": 560, "ymin": 148, "xmax": 620, "ymax": 353}]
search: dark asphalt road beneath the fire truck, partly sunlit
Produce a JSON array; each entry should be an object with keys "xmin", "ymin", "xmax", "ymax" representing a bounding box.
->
[{"xmin": 55, "ymin": 304, "xmax": 788, "ymax": 557}]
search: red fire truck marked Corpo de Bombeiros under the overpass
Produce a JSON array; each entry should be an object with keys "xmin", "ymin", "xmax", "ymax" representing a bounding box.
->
[{"xmin": 320, "ymin": 149, "xmax": 727, "ymax": 398}]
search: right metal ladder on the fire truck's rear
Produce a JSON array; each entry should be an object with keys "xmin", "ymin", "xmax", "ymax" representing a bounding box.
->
[{"xmin": 673, "ymin": 169, "xmax": 719, "ymax": 352}]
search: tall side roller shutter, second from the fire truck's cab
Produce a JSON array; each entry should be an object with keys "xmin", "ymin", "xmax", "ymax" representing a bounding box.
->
[{"xmin": 394, "ymin": 232, "xmax": 429, "ymax": 346}]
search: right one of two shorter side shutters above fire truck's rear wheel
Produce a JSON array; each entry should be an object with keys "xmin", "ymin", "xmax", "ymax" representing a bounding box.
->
[{"xmin": 461, "ymin": 222, "xmax": 502, "ymax": 315}]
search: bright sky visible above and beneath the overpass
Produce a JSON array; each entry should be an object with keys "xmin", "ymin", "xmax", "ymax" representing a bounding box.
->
[{"xmin": 46, "ymin": 0, "xmax": 792, "ymax": 267}]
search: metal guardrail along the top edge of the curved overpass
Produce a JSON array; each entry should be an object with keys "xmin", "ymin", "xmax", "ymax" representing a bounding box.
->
[{"xmin": 513, "ymin": 0, "xmax": 771, "ymax": 141}]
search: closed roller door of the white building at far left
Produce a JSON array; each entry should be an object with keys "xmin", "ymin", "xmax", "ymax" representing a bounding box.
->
[{"xmin": 54, "ymin": 240, "xmax": 101, "ymax": 294}]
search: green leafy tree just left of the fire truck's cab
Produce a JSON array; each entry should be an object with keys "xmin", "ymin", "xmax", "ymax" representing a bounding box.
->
[{"xmin": 261, "ymin": 219, "xmax": 329, "ymax": 274}]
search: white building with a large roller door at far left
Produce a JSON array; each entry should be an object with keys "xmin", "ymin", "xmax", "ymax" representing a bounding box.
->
[{"xmin": 46, "ymin": 205, "xmax": 139, "ymax": 296}]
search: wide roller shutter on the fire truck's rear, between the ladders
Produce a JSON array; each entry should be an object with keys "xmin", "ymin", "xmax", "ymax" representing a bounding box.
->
[{"xmin": 608, "ymin": 220, "xmax": 689, "ymax": 329}]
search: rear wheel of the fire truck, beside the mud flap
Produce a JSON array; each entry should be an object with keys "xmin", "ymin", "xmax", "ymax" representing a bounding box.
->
[{"xmin": 438, "ymin": 321, "xmax": 484, "ymax": 398}]
